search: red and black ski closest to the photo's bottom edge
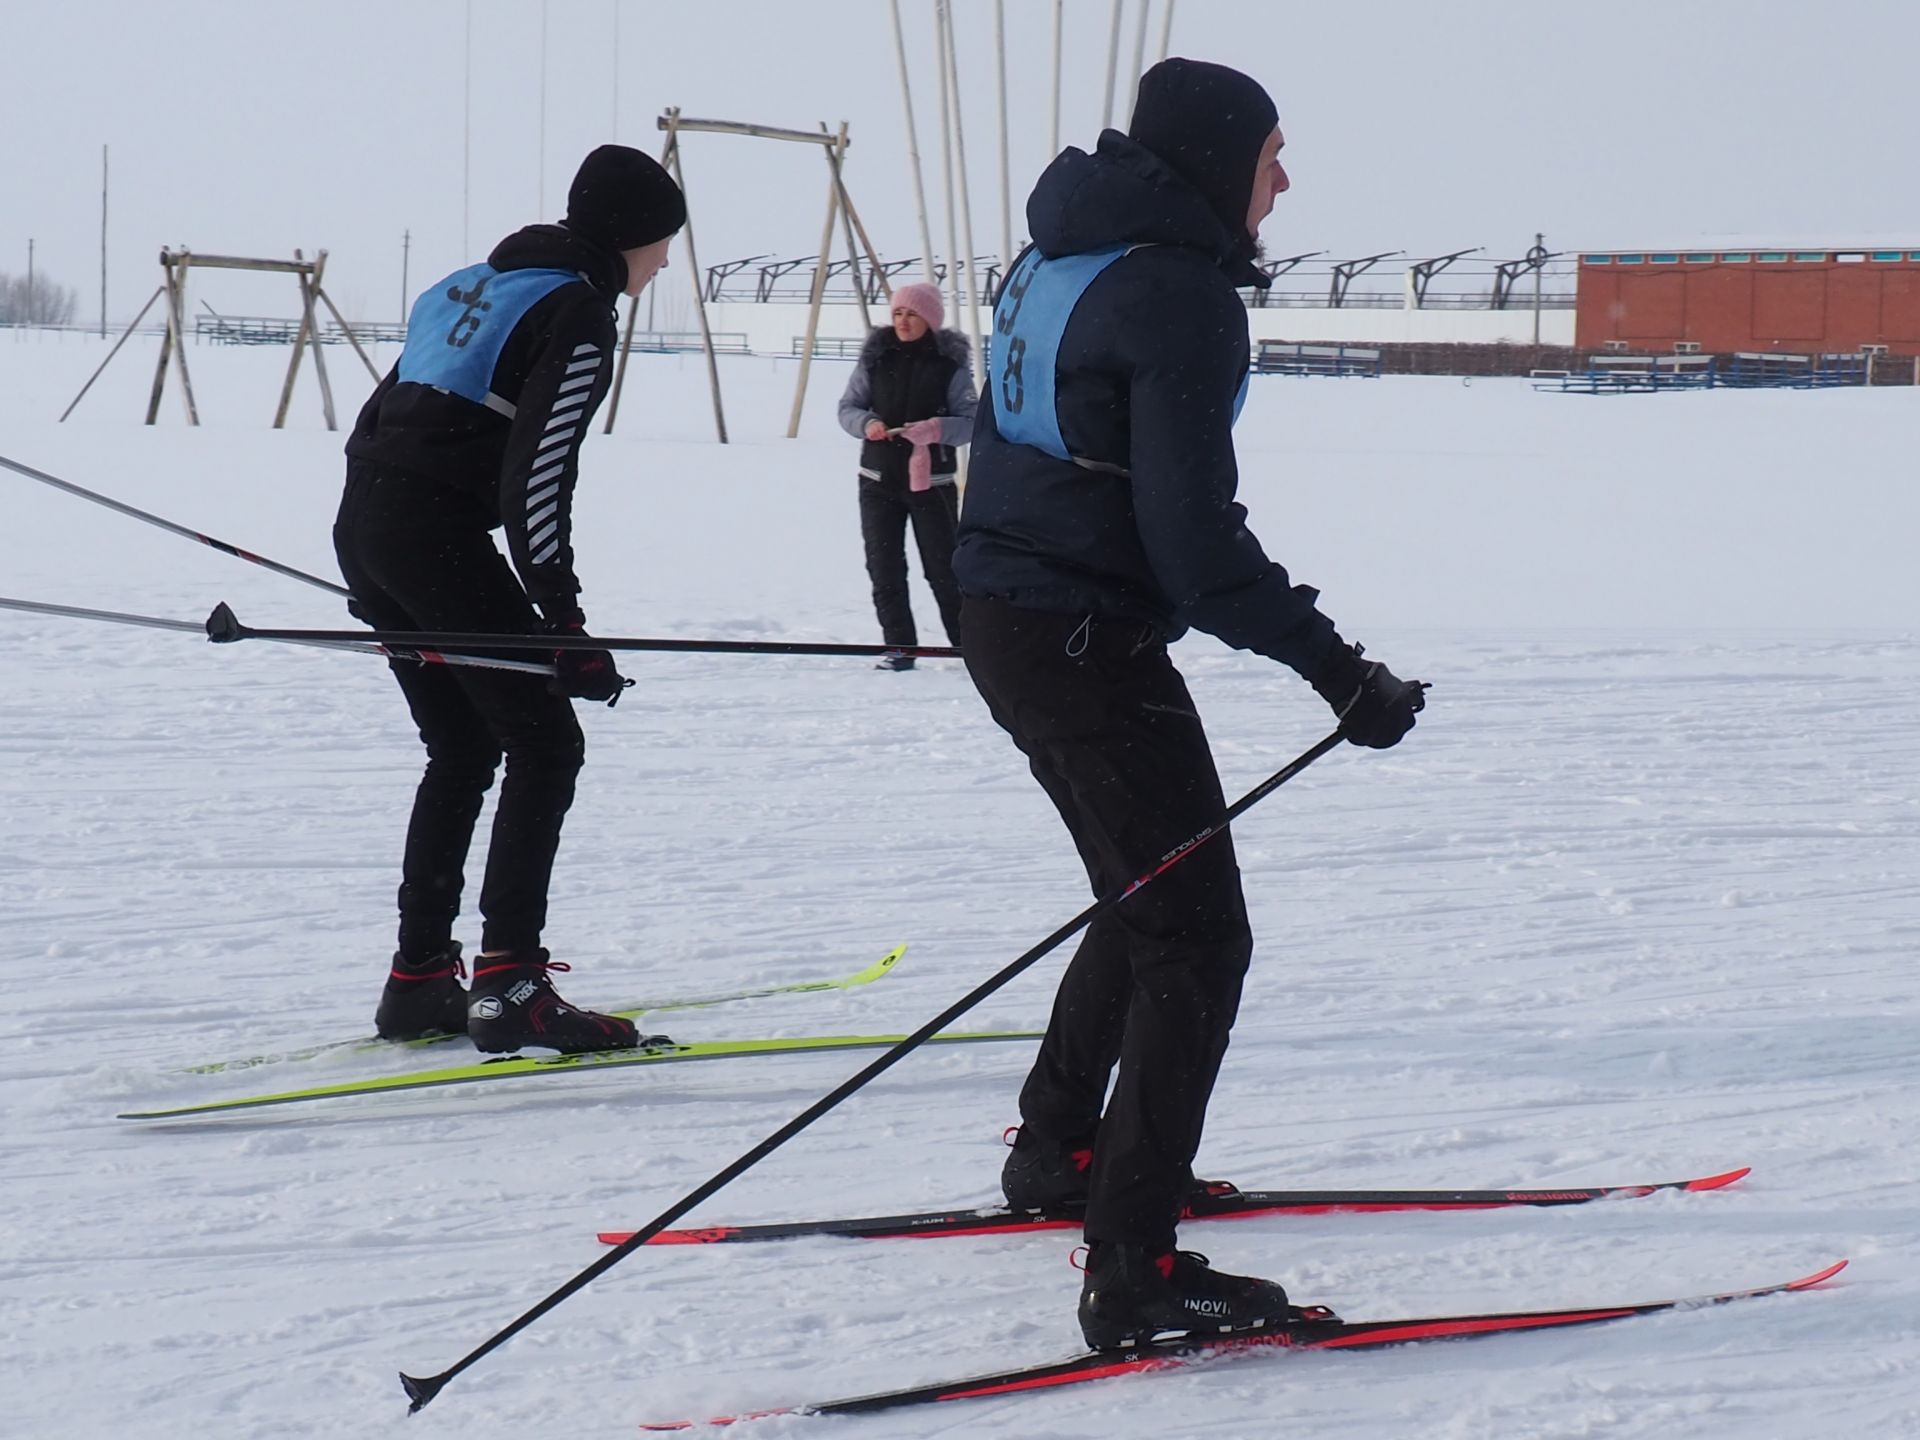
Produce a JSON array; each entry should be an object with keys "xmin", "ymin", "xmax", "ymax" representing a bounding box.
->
[{"xmin": 639, "ymin": 1260, "xmax": 1847, "ymax": 1430}]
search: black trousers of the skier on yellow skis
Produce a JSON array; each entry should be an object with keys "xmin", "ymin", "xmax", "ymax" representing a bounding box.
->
[{"xmin": 334, "ymin": 459, "xmax": 586, "ymax": 958}]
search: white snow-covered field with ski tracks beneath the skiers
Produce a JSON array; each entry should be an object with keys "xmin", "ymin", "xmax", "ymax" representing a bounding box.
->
[{"xmin": 0, "ymin": 338, "xmax": 1920, "ymax": 1440}]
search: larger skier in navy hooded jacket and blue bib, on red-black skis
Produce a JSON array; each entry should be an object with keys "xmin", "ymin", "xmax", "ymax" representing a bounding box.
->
[{"xmin": 954, "ymin": 60, "xmax": 1421, "ymax": 1348}]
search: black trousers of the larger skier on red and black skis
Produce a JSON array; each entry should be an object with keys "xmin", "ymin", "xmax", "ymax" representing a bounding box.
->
[{"xmin": 960, "ymin": 597, "xmax": 1254, "ymax": 1254}]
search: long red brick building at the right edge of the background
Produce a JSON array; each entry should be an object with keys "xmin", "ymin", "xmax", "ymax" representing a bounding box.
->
[{"xmin": 1574, "ymin": 250, "xmax": 1920, "ymax": 355}]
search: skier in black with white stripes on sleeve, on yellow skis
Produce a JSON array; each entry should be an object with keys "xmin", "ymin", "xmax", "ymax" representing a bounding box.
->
[{"xmin": 334, "ymin": 146, "xmax": 687, "ymax": 1052}]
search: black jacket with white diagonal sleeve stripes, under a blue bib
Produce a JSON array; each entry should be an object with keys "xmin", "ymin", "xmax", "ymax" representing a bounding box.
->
[{"xmin": 346, "ymin": 225, "xmax": 626, "ymax": 614}]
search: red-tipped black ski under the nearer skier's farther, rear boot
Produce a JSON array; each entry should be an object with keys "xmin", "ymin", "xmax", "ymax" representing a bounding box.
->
[{"xmin": 599, "ymin": 1165, "xmax": 1749, "ymax": 1244}]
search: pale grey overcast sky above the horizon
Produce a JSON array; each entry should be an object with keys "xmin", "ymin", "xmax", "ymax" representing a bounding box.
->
[{"xmin": 0, "ymin": 0, "xmax": 1920, "ymax": 323}]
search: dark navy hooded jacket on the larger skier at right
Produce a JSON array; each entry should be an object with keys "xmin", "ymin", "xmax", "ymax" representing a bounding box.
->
[{"xmin": 954, "ymin": 131, "xmax": 1340, "ymax": 680}]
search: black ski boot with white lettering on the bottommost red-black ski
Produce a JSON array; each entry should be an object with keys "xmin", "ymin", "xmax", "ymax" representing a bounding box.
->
[{"xmin": 1079, "ymin": 1242, "xmax": 1300, "ymax": 1350}]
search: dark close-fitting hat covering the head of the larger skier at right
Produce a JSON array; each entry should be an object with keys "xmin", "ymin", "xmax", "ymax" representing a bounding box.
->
[{"xmin": 1127, "ymin": 60, "xmax": 1281, "ymax": 238}]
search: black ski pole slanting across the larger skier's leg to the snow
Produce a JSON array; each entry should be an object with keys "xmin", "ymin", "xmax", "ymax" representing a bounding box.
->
[{"xmin": 399, "ymin": 730, "xmax": 1346, "ymax": 1415}]
